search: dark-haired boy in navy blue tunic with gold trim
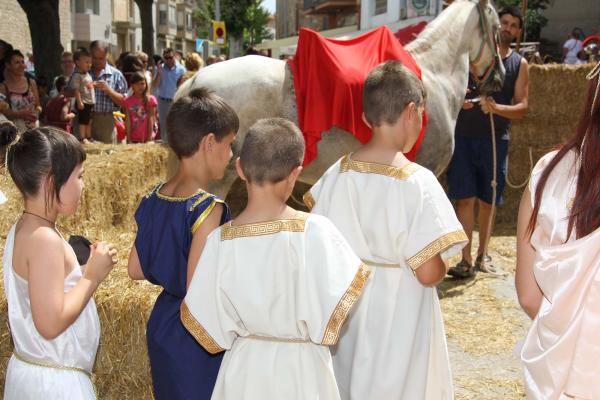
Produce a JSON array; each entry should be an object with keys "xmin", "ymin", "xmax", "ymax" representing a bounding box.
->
[{"xmin": 128, "ymin": 89, "xmax": 239, "ymax": 400}]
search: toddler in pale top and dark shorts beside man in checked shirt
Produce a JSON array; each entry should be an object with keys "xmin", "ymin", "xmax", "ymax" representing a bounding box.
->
[{"xmin": 69, "ymin": 48, "xmax": 96, "ymax": 143}]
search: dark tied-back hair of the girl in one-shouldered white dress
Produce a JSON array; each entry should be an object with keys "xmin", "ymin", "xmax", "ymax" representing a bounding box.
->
[{"xmin": 6, "ymin": 127, "xmax": 86, "ymax": 209}]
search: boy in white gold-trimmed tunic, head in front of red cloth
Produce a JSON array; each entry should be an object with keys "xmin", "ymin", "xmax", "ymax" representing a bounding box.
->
[{"xmin": 304, "ymin": 61, "xmax": 467, "ymax": 400}]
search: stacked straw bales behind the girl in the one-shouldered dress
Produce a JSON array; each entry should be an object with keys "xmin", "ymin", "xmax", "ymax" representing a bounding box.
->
[{"xmin": 0, "ymin": 144, "xmax": 168, "ymax": 399}]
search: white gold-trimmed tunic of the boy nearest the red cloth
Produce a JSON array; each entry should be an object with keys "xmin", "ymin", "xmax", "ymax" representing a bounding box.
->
[{"xmin": 304, "ymin": 155, "xmax": 467, "ymax": 400}]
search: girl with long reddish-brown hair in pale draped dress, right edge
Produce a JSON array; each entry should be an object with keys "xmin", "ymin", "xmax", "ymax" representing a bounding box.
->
[{"xmin": 515, "ymin": 63, "xmax": 600, "ymax": 400}]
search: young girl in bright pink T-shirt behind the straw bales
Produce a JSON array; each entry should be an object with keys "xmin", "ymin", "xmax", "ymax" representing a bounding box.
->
[{"xmin": 123, "ymin": 72, "xmax": 157, "ymax": 143}]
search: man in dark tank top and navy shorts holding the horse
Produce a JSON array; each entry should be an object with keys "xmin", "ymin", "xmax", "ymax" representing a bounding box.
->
[{"xmin": 448, "ymin": 7, "xmax": 529, "ymax": 278}]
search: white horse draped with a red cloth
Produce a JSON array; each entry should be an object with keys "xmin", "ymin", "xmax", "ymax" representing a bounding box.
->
[{"xmin": 175, "ymin": 0, "xmax": 504, "ymax": 198}]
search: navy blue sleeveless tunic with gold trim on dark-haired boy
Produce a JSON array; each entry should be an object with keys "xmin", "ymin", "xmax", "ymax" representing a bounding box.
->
[{"xmin": 135, "ymin": 184, "xmax": 231, "ymax": 400}]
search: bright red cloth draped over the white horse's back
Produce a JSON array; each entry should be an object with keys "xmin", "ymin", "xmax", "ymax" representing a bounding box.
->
[{"xmin": 289, "ymin": 26, "xmax": 427, "ymax": 165}]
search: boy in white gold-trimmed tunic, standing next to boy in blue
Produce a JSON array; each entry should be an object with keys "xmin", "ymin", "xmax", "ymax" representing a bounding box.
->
[{"xmin": 181, "ymin": 118, "xmax": 369, "ymax": 400}]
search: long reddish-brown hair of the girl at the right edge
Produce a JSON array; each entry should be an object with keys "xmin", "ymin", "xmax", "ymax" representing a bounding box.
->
[{"xmin": 527, "ymin": 76, "xmax": 600, "ymax": 238}]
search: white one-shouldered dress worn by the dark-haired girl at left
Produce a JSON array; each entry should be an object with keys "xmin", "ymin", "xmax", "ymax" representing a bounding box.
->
[{"xmin": 3, "ymin": 225, "xmax": 100, "ymax": 400}]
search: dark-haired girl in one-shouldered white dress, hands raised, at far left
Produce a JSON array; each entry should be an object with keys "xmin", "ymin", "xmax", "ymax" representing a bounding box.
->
[{"xmin": 3, "ymin": 128, "xmax": 116, "ymax": 400}]
